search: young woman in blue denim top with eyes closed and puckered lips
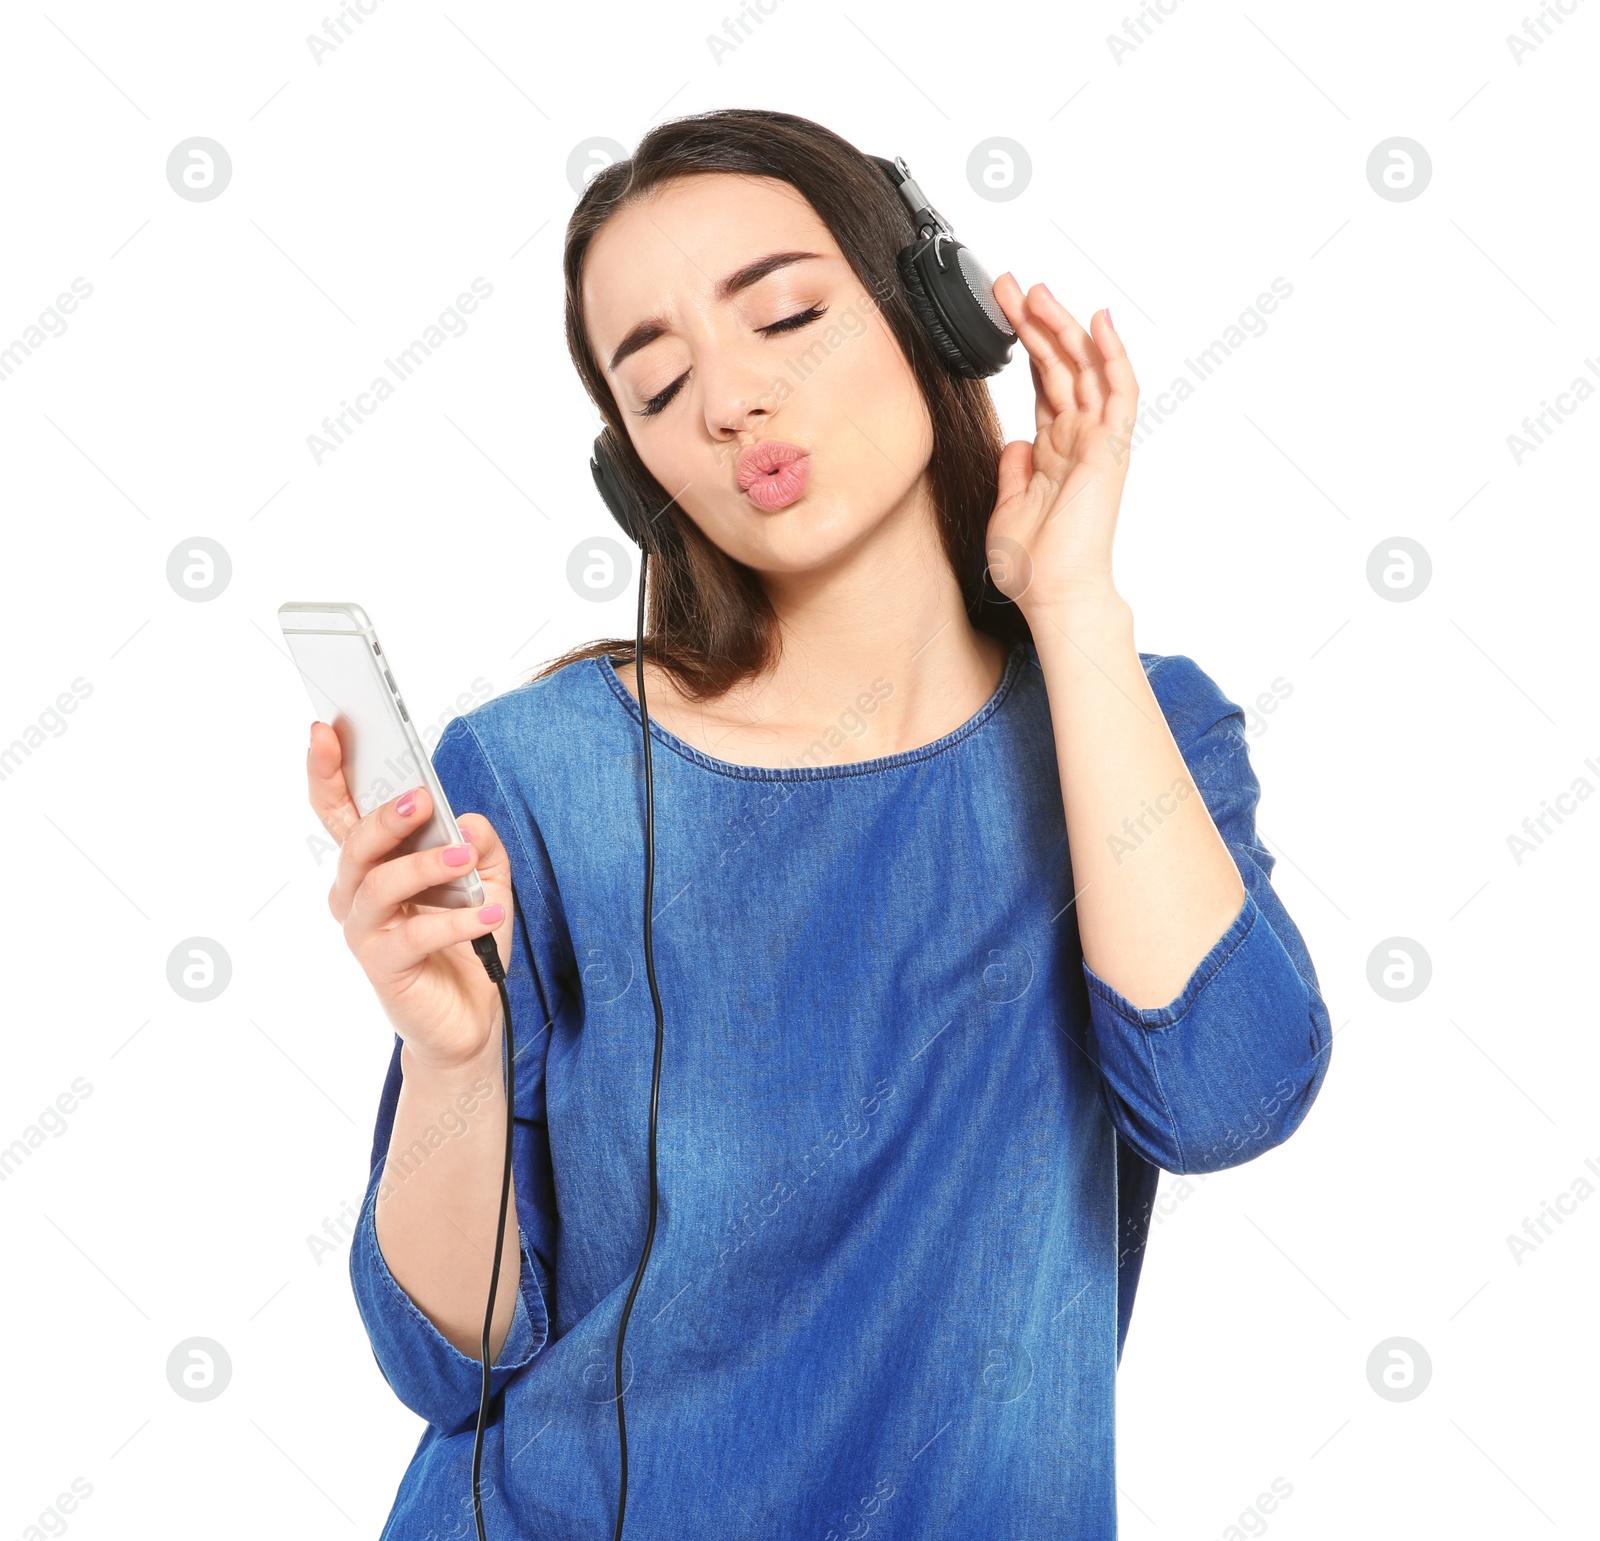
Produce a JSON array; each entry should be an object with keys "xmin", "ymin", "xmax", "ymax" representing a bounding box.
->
[{"xmin": 309, "ymin": 110, "xmax": 1330, "ymax": 1541}]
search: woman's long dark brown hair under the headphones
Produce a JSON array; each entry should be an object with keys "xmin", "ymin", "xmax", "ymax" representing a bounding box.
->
[{"xmin": 533, "ymin": 107, "xmax": 1029, "ymax": 701}]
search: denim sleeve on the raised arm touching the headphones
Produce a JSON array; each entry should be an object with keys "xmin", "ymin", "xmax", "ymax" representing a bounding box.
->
[{"xmin": 1083, "ymin": 654, "xmax": 1333, "ymax": 1173}]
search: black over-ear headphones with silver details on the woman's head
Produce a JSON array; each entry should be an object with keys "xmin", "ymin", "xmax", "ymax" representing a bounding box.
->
[{"xmin": 589, "ymin": 155, "xmax": 1016, "ymax": 547}]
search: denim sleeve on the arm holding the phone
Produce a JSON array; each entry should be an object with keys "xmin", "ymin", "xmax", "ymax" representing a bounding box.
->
[{"xmin": 350, "ymin": 717, "xmax": 558, "ymax": 1432}]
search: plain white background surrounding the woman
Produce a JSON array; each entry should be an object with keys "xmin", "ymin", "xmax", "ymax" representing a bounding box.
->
[{"xmin": 0, "ymin": 0, "xmax": 1600, "ymax": 1541}]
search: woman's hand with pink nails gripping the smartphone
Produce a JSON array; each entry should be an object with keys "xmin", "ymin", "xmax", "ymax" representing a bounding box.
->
[{"xmin": 306, "ymin": 722, "xmax": 512, "ymax": 1071}]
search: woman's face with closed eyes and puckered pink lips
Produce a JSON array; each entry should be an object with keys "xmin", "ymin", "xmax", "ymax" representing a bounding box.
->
[{"xmin": 582, "ymin": 173, "xmax": 933, "ymax": 574}]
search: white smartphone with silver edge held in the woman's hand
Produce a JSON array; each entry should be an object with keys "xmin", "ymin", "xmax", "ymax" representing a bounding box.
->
[{"xmin": 278, "ymin": 600, "xmax": 483, "ymax": 909}]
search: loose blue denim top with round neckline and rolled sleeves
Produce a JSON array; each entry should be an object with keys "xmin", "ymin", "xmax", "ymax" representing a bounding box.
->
[{"xmin": 350, "ymin": 645, "xmax": 1330, "ymax": 1541}]
